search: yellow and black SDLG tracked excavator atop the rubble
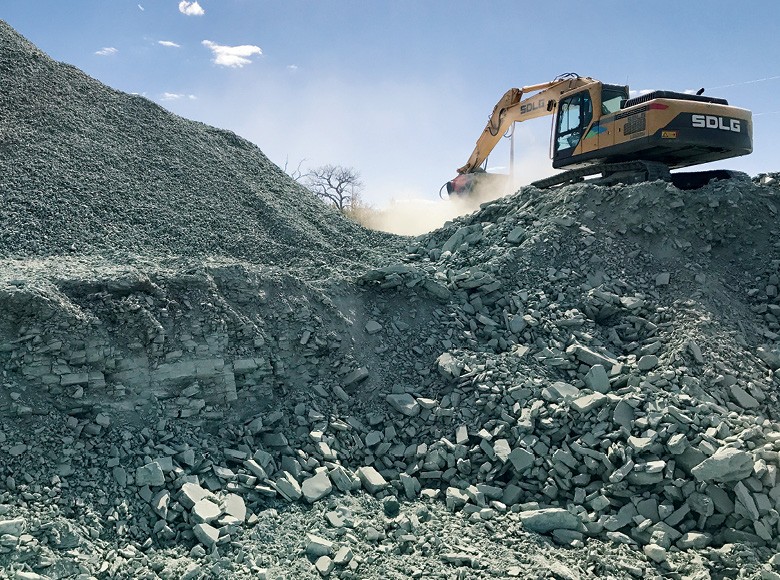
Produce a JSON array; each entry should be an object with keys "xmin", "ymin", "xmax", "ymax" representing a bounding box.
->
[{"xmin": 442, "ymin": 73, "xmax": 753, "ymax": 195}]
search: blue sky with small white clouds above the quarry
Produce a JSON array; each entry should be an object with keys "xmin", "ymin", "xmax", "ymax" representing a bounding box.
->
[{"xmin": 0, "ymin": 0, "xmax": 780, "ymax": 206}]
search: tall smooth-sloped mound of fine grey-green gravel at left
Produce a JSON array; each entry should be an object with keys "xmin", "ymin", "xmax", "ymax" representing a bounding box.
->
[{"xmin": 0, "ymin": 21, "xmax": 391, "ymax": 272}]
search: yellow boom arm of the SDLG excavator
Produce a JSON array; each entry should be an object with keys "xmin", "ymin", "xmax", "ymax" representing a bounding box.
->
[{"xmin": 458, "ymin": 75, "xmax": 598, "ymax": 174}]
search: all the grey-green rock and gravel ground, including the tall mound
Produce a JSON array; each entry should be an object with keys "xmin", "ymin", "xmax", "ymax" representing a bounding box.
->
[{"xmin": 0, "ymin": 22, "xmax": 780, "ymax": 580}]
